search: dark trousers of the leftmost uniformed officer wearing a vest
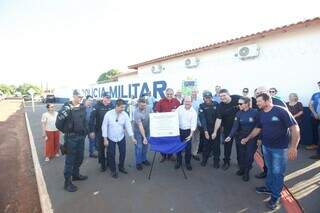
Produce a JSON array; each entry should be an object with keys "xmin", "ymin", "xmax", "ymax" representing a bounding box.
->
[{"xmin": 64, "ymin": 135, "xmax": 86, "ymax": 179}]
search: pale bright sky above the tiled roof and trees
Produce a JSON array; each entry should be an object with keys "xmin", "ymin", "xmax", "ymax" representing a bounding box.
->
[{"xmin": 0, "ymin": 0, "xmax": 320, "ymax": 88}]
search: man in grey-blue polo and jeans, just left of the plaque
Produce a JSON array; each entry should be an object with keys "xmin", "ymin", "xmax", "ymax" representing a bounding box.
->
[{"xmin": 133, "ymin": 98, "xmax": 152, "ymax": 170}]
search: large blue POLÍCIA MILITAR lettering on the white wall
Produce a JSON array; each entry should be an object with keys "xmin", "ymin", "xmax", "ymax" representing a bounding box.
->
[{"xmin": 82, "ymin": 81, "xmax": 167, "ymax": 98}]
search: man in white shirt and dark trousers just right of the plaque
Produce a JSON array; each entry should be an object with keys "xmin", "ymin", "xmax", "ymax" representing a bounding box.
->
[{"xmin": 174, "ymin": 96, "xmax": 197, "ymax": 171}]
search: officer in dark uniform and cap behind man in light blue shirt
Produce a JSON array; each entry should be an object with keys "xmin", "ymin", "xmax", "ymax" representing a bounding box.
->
[{"xmin": 89, "ymin": 92, "xmax": 114, "ymax": 172}]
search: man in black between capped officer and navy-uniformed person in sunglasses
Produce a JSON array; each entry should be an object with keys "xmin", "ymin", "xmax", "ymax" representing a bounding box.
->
[{"xmin": 219, "ymin": 89, "xmax": 241, "ymax": 170}]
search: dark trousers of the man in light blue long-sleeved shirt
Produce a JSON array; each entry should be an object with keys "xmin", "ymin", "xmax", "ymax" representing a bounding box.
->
[{"xmin": 107, "ymin": 138, "xmax": 126, "ymax": 172}]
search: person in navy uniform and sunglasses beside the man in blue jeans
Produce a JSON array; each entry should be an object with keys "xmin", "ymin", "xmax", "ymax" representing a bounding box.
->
[{"xmin": 225, "ymin": 97, "xmax": 258, "ymax": 181}]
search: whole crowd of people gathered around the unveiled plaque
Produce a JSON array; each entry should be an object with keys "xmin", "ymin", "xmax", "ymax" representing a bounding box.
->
[{"xmin": 42, "ymin": 82, "xmax": 320, "ymax": 209}]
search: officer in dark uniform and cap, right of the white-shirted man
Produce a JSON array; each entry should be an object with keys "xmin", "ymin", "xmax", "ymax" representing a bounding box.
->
[{"xmin": 199, "ymin": 91, "xmax": 221, "ymax": 169}]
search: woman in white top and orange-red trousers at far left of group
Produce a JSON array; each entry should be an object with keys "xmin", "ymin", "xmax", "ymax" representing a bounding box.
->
[{"xmin": 41, "ymin": 103, "xmax": 60, "ymax": 161}]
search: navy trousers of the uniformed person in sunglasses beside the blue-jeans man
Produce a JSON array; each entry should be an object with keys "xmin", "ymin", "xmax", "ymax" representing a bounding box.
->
[{"xmin": 236, "ymin": 138, "xmax": 257, "ymax": 171}]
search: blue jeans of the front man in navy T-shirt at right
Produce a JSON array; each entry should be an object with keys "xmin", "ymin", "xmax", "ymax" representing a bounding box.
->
[{"xmin": 262, "ymin": 146, "xmax": 288, "ymax": 200}]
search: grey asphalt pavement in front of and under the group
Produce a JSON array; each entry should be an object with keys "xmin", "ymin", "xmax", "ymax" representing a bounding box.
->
[{"xmin": 26, "ymin": 105, "xmax": 319, "ymax": 213}]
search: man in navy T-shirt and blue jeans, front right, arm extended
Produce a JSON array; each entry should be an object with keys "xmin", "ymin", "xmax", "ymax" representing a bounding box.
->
[{"xmin": 241, "ymin": 93, "xmax": 300, "ymax": 209}]
